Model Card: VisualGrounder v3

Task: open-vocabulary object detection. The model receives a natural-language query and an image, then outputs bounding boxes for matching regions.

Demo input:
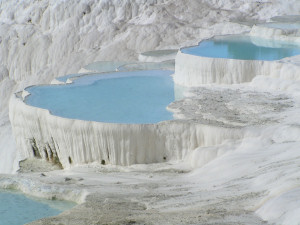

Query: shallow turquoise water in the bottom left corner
[0,190,74,225]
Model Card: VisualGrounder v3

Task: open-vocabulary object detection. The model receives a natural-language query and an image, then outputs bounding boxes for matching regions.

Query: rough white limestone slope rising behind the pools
[0,0,278,173]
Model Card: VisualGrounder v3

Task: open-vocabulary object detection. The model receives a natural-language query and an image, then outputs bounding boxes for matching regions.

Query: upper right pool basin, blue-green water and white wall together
[174,35,300,86]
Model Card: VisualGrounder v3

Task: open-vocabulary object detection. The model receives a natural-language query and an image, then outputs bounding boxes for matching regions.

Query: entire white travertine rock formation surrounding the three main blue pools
[0,0,300,225]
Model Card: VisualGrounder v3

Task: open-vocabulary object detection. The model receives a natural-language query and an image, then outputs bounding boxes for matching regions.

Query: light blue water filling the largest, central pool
[25,70,174,124]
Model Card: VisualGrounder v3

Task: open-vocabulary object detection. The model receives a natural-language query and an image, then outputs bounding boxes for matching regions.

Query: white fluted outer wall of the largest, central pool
[9,92,243,168]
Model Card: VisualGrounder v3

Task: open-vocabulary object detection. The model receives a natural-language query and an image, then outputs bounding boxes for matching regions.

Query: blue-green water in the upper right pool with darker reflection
[181,36,300,61]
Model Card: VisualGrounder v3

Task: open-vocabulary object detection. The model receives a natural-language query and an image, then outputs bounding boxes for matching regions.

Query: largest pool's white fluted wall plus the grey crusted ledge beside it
[9,63,291,171]
